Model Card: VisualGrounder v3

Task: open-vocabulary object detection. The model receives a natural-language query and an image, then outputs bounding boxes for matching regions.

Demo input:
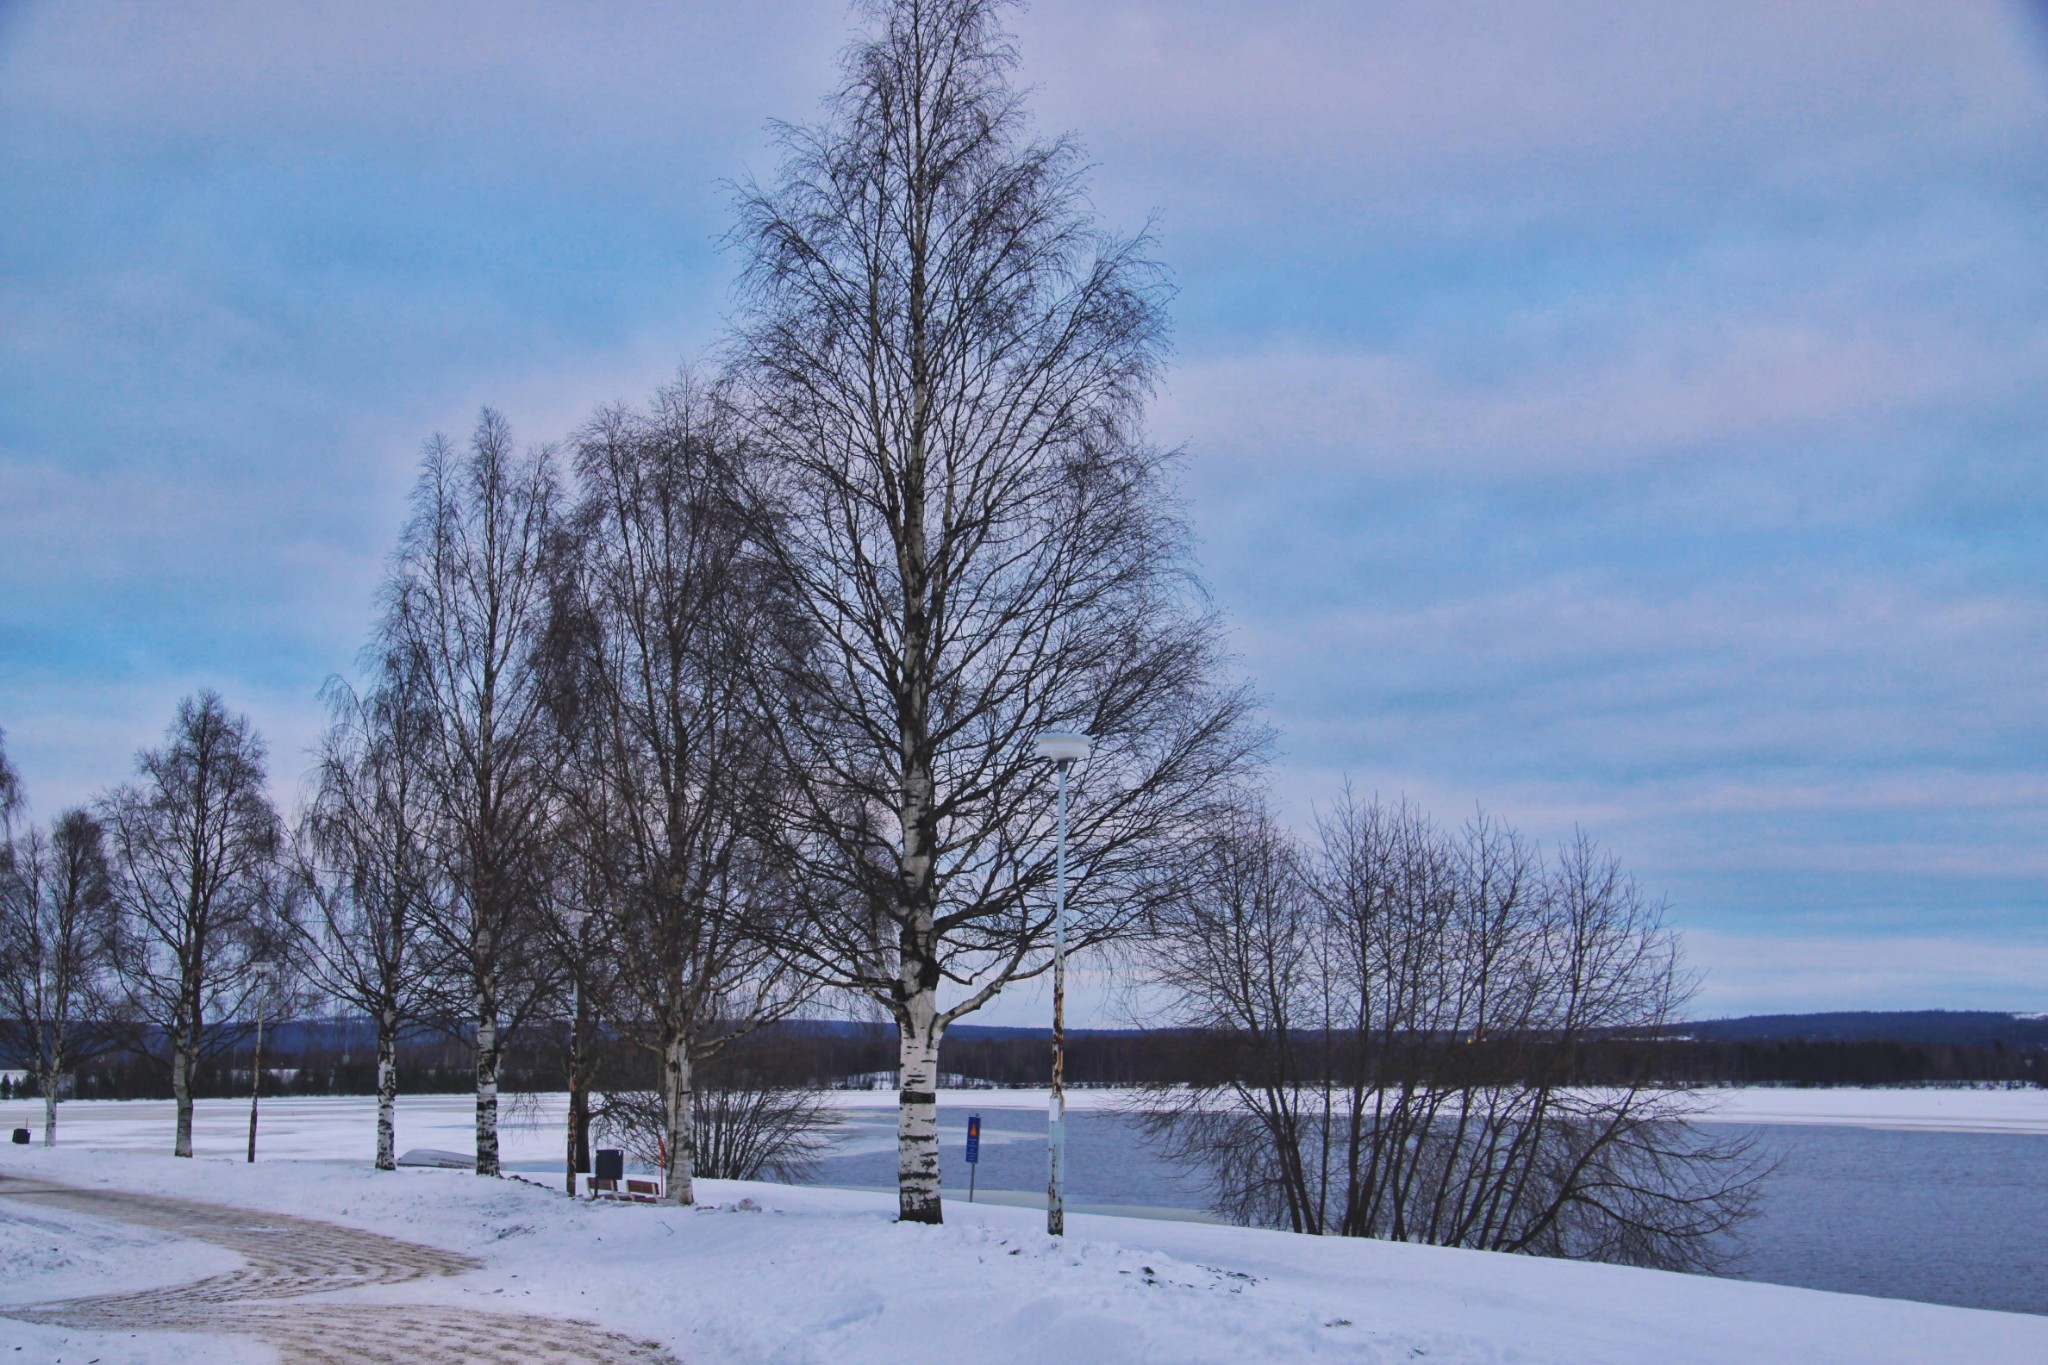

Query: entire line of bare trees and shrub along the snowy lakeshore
[0,0,1757,1265]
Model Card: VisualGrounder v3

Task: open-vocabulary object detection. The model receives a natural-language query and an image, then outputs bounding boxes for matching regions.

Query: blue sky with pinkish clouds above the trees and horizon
[0,0,2048,1021]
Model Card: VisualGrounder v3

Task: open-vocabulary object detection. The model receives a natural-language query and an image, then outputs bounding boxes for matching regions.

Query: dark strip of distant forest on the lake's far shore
[12,1011,2048,1099]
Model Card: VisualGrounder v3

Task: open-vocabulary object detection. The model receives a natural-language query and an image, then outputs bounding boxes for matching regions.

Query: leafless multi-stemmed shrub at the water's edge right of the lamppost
[1149,796,1765,1269]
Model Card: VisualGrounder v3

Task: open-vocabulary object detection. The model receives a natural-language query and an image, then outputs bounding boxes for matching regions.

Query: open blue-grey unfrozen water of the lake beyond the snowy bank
[817,1103,2048,1314]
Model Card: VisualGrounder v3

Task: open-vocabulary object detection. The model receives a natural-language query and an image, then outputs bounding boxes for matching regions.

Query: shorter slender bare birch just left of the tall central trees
[289,679,444,1171]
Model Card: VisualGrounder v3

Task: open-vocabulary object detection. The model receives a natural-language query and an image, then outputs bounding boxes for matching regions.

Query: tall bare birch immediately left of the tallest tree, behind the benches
[557,377,805,1203]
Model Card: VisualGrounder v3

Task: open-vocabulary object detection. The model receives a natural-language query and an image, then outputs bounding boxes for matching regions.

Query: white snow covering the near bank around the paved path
[0,1146,2048,1365]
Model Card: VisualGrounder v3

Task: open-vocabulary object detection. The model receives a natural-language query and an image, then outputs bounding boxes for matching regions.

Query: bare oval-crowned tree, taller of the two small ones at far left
[98,692,281,1156]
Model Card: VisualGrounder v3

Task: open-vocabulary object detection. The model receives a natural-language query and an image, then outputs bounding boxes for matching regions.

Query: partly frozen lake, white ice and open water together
[19,1091,2048,1314]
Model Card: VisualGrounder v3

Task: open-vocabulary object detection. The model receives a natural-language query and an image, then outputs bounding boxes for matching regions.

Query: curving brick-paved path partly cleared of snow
[0,1177,674,1365]
